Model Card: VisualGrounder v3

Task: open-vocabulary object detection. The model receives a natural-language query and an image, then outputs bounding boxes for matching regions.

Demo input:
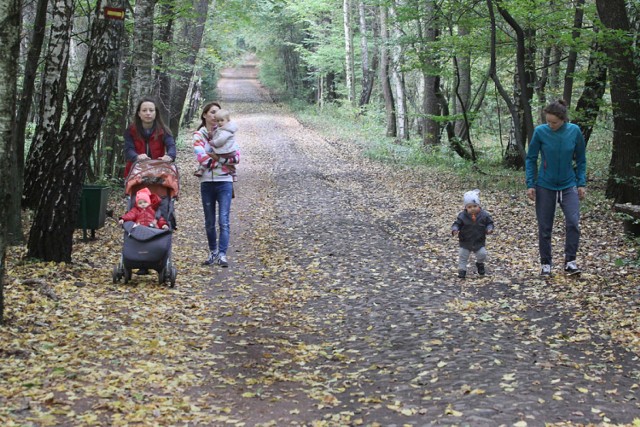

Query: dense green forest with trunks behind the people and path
[0,0,640,314]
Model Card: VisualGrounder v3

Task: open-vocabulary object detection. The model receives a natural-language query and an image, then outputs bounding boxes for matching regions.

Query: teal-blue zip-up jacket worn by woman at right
[525,122,587,191]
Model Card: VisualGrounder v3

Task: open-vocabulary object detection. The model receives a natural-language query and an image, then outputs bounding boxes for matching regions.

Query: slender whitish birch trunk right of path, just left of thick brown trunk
[389,1,409,139]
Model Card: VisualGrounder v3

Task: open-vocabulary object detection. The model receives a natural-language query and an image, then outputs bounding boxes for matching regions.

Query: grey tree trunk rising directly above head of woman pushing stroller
[129,0,156,110]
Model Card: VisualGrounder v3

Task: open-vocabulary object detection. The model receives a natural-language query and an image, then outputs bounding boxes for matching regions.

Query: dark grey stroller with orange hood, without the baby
[113,160,180,287]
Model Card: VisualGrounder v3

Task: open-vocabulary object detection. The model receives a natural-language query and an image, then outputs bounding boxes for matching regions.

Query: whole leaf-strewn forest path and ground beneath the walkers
[0,57,640,427]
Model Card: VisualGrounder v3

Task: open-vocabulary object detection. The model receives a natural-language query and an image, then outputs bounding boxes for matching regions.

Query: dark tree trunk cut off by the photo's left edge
[0,0,21,324]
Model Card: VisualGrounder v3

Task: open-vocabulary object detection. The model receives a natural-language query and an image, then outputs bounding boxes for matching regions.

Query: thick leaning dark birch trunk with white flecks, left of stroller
[27,0,124,262]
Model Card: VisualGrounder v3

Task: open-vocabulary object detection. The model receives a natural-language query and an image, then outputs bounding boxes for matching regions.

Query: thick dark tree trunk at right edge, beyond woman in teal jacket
[596,0,640,204]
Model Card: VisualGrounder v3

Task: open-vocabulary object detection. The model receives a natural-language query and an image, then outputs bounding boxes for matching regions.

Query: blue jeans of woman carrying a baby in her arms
[200,181,233,254]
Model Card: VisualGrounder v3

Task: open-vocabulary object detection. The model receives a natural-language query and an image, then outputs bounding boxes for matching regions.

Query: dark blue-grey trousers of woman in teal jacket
[536,187,580,264]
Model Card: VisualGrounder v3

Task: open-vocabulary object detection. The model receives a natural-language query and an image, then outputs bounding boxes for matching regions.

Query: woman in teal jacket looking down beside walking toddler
[525,100,587,276]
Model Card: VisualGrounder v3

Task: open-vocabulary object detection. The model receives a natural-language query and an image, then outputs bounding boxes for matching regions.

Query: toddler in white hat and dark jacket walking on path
[451,190,493,279]
